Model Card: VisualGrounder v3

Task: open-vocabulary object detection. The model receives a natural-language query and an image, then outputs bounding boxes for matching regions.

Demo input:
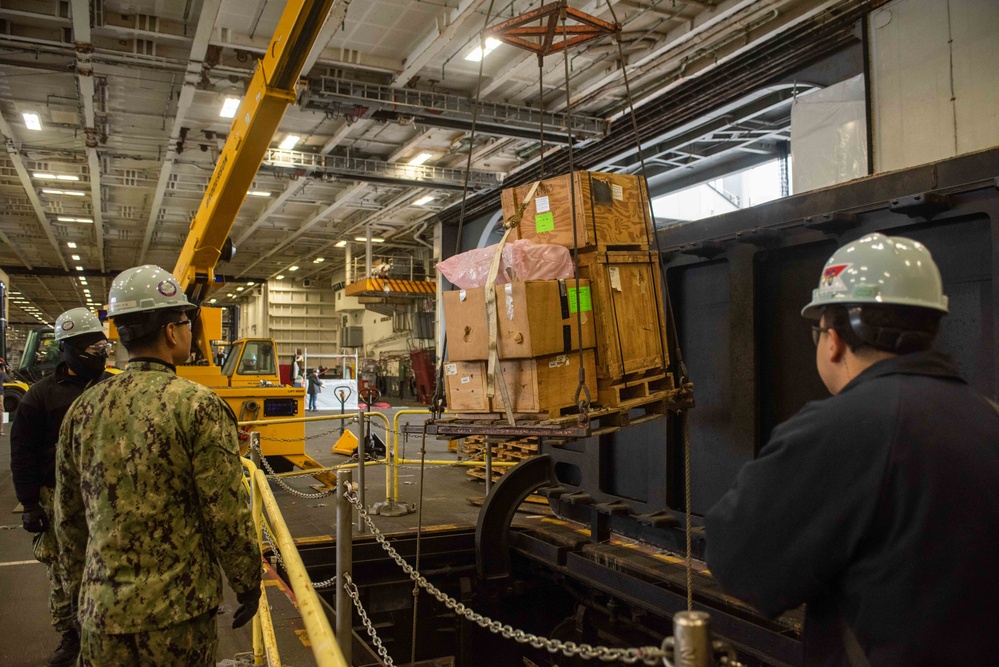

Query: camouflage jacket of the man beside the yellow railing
[55,359,261,634]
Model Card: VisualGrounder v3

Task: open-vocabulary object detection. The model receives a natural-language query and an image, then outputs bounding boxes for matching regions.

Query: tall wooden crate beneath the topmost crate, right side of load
[577,251,669,384]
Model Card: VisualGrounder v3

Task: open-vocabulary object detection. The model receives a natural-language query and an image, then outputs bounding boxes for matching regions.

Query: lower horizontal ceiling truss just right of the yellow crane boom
[263,148,501,190]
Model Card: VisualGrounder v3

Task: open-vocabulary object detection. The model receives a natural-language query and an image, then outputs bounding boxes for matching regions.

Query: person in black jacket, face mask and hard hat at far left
[10,308,111,667]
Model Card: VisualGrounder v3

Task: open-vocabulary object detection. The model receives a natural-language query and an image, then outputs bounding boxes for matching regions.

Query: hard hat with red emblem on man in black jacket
[801,234,947,320]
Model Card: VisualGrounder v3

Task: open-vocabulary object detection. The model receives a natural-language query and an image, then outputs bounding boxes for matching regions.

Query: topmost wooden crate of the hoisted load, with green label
[501,171,651,250]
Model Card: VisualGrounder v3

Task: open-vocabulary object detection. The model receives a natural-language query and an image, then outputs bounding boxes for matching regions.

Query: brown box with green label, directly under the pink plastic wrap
[444,278,595,361]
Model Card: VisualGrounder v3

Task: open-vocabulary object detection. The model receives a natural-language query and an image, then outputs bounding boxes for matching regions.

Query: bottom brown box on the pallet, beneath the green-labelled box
[444,350,596,414]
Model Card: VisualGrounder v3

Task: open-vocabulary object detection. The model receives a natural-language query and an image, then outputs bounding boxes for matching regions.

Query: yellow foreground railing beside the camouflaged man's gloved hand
[241,459,349,667]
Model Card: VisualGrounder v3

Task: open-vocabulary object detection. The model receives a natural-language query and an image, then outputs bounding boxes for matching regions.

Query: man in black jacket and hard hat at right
[705,234,999,667]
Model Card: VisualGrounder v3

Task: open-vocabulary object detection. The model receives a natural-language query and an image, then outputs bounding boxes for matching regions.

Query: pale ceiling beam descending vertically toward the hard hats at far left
[70,0,104,271]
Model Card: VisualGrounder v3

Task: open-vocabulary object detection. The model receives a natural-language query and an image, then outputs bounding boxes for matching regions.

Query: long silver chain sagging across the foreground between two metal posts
[343,487,666,665]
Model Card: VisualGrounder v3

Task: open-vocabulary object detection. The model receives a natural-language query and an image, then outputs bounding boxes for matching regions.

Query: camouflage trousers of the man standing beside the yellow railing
[77,611,218,667]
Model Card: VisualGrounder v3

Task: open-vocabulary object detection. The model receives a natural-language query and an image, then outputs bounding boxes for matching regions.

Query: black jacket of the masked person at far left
[10,362,111,505]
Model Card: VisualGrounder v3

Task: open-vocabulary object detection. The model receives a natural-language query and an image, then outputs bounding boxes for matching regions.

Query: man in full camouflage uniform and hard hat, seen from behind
[55,265,261,666]
